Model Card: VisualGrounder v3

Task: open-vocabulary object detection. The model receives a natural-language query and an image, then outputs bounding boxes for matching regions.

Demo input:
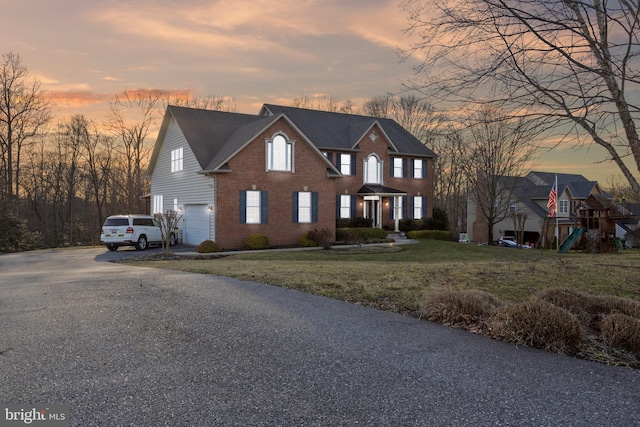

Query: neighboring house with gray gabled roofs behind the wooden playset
[467,172,609,244]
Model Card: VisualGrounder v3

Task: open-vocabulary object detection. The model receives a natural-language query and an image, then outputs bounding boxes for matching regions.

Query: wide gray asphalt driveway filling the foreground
[0,248,640,426]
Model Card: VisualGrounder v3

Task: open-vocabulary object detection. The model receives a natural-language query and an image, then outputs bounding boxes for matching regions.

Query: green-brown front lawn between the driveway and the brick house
[129,240,640,315]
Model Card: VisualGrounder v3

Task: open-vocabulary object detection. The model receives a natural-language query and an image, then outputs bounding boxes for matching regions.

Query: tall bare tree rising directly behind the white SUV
[104,90,163,212]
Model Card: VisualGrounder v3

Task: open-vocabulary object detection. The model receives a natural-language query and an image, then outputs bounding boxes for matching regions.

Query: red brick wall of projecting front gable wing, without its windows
[216,119,336,249]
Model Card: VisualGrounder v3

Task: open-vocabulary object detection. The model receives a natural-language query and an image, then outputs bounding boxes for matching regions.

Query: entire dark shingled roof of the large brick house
[148,104,435,176]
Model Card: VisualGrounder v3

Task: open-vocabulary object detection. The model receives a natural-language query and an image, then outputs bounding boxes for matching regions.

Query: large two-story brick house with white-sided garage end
[148,104,435,249]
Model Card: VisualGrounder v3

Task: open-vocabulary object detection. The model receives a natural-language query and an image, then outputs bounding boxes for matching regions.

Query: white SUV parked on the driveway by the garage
[100,215,176,251]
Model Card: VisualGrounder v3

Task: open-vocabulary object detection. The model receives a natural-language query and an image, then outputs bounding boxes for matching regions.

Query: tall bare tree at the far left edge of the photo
[0,52,51,211]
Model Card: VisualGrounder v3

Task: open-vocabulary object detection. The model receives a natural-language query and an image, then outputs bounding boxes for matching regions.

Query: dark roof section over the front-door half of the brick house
[260,104,436,157]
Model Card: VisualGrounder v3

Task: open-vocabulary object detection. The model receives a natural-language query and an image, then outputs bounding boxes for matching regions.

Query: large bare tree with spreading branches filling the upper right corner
[402,0,640,193]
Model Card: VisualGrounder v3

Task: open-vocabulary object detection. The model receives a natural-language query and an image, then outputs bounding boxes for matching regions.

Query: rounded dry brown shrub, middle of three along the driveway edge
[487,300,584,353]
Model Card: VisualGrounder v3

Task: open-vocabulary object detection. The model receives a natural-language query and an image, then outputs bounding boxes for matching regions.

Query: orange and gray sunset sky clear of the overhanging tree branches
[0,0,618,184]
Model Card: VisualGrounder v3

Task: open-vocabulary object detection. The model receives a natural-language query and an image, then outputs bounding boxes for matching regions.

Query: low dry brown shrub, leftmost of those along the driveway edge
[420,290,502,328]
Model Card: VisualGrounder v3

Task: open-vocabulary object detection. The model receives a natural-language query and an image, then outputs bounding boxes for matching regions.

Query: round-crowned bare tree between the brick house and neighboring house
[460,107,539,244]
